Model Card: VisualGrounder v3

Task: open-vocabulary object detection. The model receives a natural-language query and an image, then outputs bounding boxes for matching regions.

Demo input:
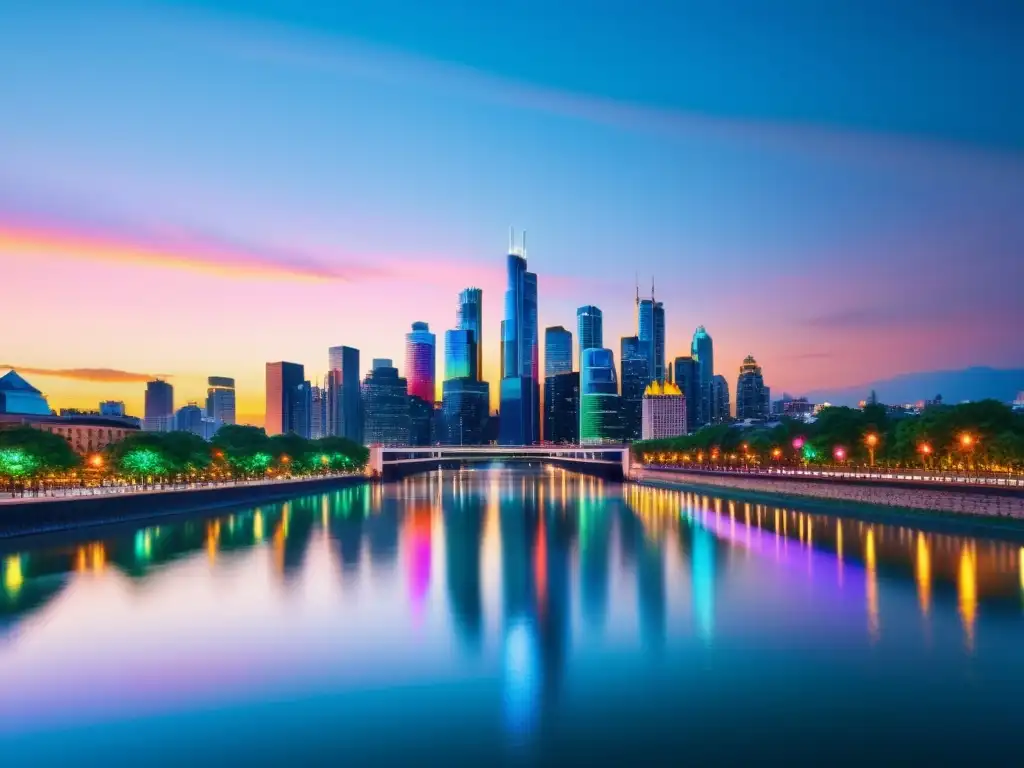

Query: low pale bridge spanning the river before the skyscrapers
[370,445,630,480]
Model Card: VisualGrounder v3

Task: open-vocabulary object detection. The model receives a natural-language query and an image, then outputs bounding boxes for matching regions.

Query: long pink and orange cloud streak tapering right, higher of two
[0,221,381,281]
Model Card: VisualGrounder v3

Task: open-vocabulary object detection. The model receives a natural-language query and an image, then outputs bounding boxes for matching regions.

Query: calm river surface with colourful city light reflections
[0,468,1024,765]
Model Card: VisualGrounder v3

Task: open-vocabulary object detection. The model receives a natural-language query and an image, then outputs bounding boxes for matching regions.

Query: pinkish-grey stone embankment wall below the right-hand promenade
[633,470,1024,520]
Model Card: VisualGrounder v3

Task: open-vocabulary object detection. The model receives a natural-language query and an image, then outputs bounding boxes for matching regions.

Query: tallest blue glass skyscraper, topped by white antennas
[500,231,541,445]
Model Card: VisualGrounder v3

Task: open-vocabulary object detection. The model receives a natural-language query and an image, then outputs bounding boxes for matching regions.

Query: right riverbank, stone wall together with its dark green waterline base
[633,470,1024,530]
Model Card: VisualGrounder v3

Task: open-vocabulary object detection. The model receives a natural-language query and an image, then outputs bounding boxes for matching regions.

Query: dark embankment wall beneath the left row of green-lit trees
[0,475,369,539]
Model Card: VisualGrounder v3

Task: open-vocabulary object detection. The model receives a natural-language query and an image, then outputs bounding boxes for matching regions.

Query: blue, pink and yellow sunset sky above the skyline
[0,0,1024,423]
